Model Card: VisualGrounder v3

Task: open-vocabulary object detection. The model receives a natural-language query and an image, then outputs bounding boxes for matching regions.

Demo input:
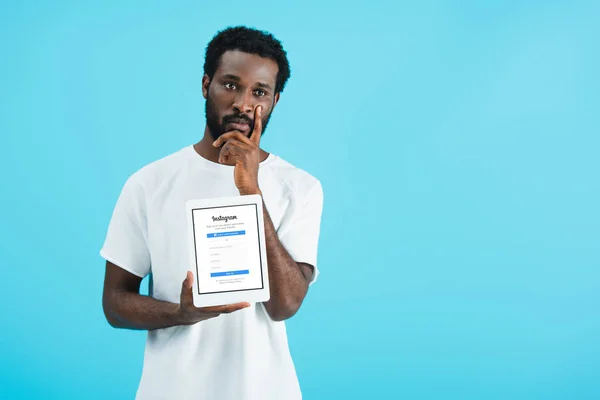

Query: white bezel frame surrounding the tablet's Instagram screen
[186,194,270,307]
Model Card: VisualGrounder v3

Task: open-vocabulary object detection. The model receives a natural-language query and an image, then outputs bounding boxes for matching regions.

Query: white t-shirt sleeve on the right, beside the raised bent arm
[278,181,323,284]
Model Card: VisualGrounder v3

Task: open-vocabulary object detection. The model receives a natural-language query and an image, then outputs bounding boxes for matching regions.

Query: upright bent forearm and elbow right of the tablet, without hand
[263,198,308,321]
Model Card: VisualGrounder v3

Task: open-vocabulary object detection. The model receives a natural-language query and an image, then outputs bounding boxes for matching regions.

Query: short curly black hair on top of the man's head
[204,26,290,93]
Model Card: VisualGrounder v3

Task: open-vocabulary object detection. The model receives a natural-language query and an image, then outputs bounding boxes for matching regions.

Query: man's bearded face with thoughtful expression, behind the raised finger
[202,50,279,140]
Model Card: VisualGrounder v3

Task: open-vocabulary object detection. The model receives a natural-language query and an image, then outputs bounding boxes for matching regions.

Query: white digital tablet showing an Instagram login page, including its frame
[186,195,270,307]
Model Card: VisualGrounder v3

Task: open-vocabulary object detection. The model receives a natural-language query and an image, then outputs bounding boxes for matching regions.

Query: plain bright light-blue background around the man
[0,0,600,399]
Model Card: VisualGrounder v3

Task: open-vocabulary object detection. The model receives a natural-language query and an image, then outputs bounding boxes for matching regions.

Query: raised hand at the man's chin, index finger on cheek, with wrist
[213,106,262,195]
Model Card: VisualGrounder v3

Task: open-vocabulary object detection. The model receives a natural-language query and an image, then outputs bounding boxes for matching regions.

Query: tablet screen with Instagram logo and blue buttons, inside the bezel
[192,204,264,294]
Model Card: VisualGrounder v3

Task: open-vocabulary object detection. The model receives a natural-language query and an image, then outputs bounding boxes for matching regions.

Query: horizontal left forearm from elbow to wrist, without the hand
[103,291,183,330]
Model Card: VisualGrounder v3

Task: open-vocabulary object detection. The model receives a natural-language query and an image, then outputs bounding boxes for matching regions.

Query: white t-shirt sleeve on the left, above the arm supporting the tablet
[100,175,150,278]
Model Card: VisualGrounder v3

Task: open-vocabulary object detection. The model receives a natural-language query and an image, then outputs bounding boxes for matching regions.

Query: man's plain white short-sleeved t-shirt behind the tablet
[100,146,323,400]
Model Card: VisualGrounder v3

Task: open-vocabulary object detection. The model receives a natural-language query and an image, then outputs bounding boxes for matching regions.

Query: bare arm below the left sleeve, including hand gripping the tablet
[102,261,250,330]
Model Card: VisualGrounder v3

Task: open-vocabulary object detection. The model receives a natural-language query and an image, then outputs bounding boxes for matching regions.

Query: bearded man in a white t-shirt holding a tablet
[100,27,323,400]
